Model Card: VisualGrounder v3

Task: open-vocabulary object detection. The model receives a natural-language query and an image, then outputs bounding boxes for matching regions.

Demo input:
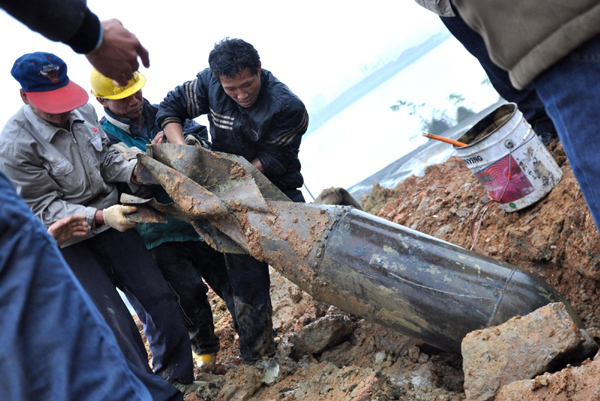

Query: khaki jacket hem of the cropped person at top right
[453,0,600,89]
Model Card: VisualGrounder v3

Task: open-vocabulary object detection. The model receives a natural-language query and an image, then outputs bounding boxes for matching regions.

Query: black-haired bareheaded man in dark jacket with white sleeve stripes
[157,38,308,362]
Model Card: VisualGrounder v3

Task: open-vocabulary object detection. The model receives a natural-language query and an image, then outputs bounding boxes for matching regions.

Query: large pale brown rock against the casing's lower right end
[461,303,595,401]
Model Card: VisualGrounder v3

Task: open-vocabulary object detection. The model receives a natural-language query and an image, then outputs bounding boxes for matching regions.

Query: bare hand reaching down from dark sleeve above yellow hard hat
[85,18,150,86]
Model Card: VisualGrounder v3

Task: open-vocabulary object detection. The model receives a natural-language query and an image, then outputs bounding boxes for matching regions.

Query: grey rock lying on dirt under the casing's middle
[288,315,353,356]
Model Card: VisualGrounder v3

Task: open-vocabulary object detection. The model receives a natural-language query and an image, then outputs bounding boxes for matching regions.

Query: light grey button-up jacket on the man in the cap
[0,104,135,245]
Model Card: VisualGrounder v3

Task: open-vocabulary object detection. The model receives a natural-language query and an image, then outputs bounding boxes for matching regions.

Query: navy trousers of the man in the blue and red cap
[61,229,194,383]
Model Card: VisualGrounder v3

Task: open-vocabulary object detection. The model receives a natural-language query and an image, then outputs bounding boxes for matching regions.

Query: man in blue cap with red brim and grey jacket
[0,52,202,396]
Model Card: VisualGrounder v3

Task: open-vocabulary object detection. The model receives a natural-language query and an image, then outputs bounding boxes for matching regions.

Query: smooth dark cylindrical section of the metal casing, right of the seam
[311,210,579,353]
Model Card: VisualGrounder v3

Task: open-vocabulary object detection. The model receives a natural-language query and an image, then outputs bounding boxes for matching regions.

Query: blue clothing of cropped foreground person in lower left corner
[0,172,183,401]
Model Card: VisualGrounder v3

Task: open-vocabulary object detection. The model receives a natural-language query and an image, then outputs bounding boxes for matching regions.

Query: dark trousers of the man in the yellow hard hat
[150,241,234,355]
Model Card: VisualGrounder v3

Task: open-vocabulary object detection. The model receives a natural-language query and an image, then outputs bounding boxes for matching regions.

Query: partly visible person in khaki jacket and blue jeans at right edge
[453,0,600,234]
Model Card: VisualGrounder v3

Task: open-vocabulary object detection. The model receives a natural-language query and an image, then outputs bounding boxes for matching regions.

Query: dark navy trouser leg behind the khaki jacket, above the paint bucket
[440,13,556,135]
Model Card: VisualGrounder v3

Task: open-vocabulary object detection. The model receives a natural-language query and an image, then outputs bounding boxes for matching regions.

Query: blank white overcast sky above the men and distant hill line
[0,0,444,123]
